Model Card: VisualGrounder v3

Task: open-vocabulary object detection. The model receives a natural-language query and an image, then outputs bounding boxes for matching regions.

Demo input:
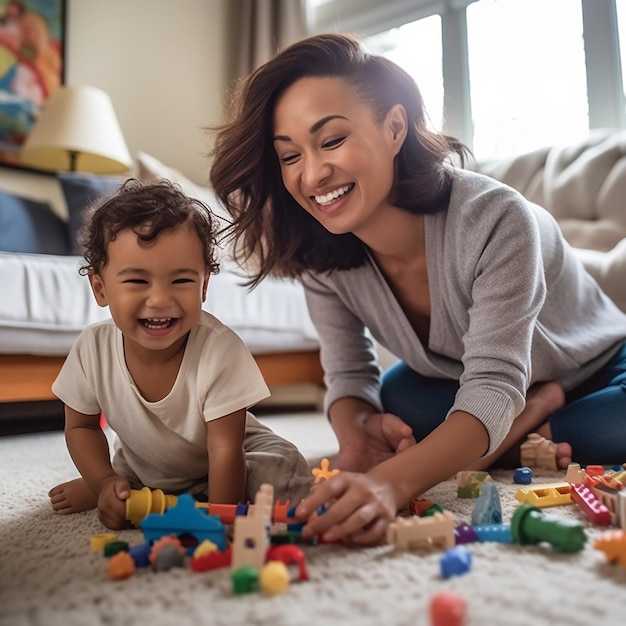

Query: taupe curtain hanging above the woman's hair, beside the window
[233,0,307,78]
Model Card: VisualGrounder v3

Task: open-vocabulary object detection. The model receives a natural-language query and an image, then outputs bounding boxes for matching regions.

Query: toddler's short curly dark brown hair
[77,178,219,275]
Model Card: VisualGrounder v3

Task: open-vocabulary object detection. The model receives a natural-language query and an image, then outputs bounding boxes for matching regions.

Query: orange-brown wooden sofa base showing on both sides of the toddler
[0,350,324,402]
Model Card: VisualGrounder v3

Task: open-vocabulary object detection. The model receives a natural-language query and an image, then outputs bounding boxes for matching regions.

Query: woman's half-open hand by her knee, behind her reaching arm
[333,413,415,472]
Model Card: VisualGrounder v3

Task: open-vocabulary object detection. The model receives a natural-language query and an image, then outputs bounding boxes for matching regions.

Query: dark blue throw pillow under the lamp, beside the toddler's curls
[57,172,124,254]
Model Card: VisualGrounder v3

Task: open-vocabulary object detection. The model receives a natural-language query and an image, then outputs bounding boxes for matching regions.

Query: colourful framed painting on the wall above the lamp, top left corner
[0,0,66,167]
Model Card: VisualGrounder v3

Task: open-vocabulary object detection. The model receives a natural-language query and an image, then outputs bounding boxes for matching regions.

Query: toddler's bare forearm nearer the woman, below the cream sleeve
[207,409,246,504]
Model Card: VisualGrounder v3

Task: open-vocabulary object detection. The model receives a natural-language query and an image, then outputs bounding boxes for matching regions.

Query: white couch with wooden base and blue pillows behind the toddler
[0,152,323,431]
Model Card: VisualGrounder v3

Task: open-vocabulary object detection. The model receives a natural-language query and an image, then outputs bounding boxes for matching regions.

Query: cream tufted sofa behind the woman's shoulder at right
[474,130,626,311]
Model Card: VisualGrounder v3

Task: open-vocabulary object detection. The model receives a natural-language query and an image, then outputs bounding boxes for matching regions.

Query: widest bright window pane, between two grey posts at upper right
[467,0,589,158]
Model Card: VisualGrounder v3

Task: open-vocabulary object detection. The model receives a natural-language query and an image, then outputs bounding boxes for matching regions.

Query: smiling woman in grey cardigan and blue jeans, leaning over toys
[211,35,626,543]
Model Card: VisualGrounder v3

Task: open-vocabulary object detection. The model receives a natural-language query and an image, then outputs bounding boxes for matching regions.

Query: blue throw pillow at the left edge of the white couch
[0,190,70,254]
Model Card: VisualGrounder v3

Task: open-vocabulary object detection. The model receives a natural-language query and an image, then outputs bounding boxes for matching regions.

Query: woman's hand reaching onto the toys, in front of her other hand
[296,472,396,545]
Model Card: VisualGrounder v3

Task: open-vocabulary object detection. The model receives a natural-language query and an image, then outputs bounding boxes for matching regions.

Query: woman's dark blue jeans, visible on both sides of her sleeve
[381,344,626,465]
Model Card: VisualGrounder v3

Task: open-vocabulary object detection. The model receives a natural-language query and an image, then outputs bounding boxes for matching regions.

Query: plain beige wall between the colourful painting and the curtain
[65,0,230,183]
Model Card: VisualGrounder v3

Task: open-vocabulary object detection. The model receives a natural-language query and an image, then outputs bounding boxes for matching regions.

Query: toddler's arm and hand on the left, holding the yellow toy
[65,406,130,529]
